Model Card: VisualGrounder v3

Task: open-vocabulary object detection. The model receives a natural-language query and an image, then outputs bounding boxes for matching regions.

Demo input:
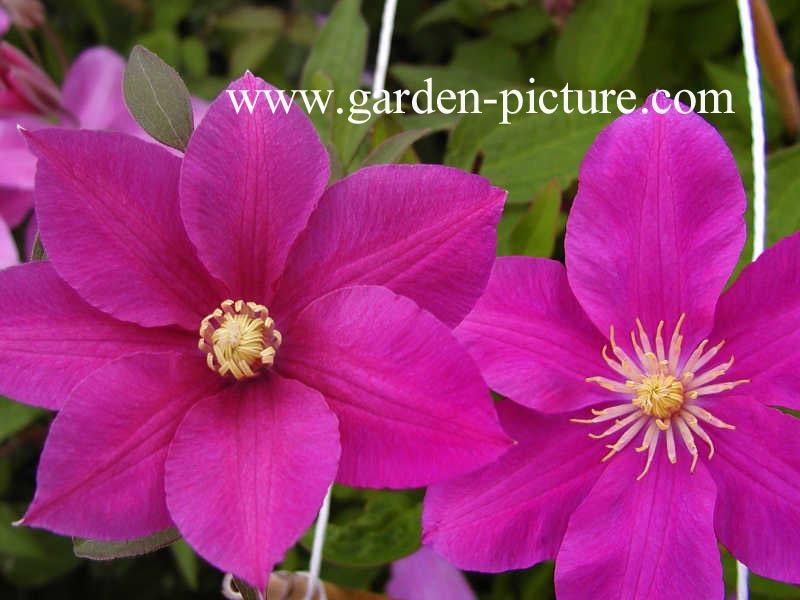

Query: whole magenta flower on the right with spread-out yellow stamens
[423,99,800,600]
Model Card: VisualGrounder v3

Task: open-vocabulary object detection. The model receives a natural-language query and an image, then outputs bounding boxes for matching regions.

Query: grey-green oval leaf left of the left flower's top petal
[122,46,194,151]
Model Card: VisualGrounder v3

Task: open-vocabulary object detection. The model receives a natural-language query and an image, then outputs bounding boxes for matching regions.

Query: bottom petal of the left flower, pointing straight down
[166,373,339,589]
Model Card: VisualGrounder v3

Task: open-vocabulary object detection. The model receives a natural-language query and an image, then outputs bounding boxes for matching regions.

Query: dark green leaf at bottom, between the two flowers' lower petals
[303,490,422,567]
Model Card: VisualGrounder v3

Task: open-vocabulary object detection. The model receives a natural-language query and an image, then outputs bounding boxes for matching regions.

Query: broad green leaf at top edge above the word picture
[556,0,650,89]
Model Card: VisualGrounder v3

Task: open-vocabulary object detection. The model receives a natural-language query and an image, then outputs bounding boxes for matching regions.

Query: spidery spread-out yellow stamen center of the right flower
[572,315,748,479]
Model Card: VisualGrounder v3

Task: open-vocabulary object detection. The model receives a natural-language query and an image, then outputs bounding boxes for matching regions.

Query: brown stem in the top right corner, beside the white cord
[750,0,800,138]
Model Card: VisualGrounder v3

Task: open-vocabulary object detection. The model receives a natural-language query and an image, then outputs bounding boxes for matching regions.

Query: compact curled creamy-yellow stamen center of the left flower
[197,300,282,379]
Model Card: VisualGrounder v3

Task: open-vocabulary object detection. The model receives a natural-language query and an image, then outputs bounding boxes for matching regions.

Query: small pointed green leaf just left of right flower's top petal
[509,181,561,258]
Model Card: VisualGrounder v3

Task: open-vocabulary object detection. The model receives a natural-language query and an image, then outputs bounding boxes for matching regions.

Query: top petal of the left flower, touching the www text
[181,73,329,308]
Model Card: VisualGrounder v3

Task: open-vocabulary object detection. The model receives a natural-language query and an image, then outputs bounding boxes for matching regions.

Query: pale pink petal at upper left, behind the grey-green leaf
[62,46,140,137]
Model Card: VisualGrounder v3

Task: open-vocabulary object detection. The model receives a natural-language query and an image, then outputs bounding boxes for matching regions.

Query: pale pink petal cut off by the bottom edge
[386,546,477,600]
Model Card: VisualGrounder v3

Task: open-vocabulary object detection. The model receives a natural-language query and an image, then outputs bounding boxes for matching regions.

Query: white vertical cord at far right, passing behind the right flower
[736,0,767,600]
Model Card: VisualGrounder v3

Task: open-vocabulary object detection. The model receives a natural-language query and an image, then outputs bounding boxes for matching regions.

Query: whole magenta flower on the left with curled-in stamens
[0,75,509,588]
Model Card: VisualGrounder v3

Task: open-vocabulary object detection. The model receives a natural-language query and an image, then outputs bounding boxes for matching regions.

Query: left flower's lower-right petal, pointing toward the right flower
[275,286,509,488]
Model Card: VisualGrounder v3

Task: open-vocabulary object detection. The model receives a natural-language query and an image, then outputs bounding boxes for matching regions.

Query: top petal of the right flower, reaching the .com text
[566,96,746,345]
